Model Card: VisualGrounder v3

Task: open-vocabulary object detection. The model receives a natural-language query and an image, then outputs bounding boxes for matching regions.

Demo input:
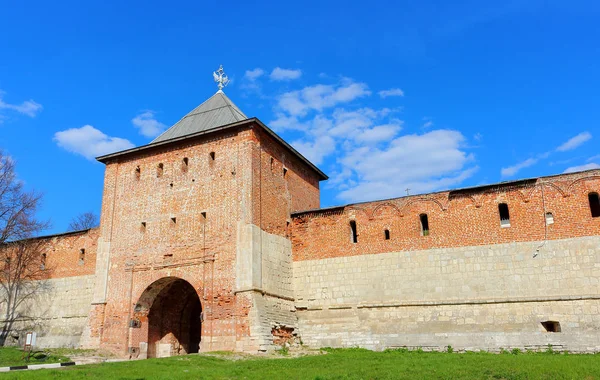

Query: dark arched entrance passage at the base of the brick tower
[133,277,202,358]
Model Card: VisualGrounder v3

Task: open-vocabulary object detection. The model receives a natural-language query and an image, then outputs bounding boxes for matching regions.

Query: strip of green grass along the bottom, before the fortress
[0,349,600,380]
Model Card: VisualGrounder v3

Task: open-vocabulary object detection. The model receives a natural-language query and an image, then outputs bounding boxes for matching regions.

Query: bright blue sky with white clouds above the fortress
[0,0,600,232]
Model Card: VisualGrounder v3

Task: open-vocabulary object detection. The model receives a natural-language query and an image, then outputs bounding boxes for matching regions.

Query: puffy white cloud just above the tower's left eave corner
[54,125,134,160]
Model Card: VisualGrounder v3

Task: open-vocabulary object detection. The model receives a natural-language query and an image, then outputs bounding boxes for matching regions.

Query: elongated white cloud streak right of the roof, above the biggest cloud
[278,82,371,116]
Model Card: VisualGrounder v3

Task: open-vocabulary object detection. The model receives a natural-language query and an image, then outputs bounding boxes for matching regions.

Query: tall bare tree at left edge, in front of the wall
[0,151,48,346]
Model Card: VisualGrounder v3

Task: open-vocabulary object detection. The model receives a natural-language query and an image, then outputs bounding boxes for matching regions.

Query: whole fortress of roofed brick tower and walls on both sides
[2,87,600,358]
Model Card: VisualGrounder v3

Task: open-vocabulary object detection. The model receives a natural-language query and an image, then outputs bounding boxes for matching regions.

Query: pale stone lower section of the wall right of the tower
[294,236,600,351]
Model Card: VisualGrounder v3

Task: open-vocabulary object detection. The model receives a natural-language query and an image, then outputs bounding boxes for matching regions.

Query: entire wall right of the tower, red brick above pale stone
[292,172,600,351]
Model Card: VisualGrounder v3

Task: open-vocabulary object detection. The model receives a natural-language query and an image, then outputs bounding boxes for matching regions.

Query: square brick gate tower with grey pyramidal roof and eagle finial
[82,69,327,358]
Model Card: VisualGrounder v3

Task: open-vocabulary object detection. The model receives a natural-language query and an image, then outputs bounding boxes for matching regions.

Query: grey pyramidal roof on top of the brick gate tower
[152,90,248,143]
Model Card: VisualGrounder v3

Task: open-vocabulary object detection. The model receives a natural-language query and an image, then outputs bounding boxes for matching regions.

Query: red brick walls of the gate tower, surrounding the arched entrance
[90,126,319,353]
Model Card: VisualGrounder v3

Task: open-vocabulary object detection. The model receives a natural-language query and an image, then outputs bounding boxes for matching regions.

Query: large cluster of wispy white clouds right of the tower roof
[269,78,478,202]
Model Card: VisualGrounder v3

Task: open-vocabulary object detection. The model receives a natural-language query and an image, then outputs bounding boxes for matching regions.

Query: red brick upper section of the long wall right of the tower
[292,170,600,261]
